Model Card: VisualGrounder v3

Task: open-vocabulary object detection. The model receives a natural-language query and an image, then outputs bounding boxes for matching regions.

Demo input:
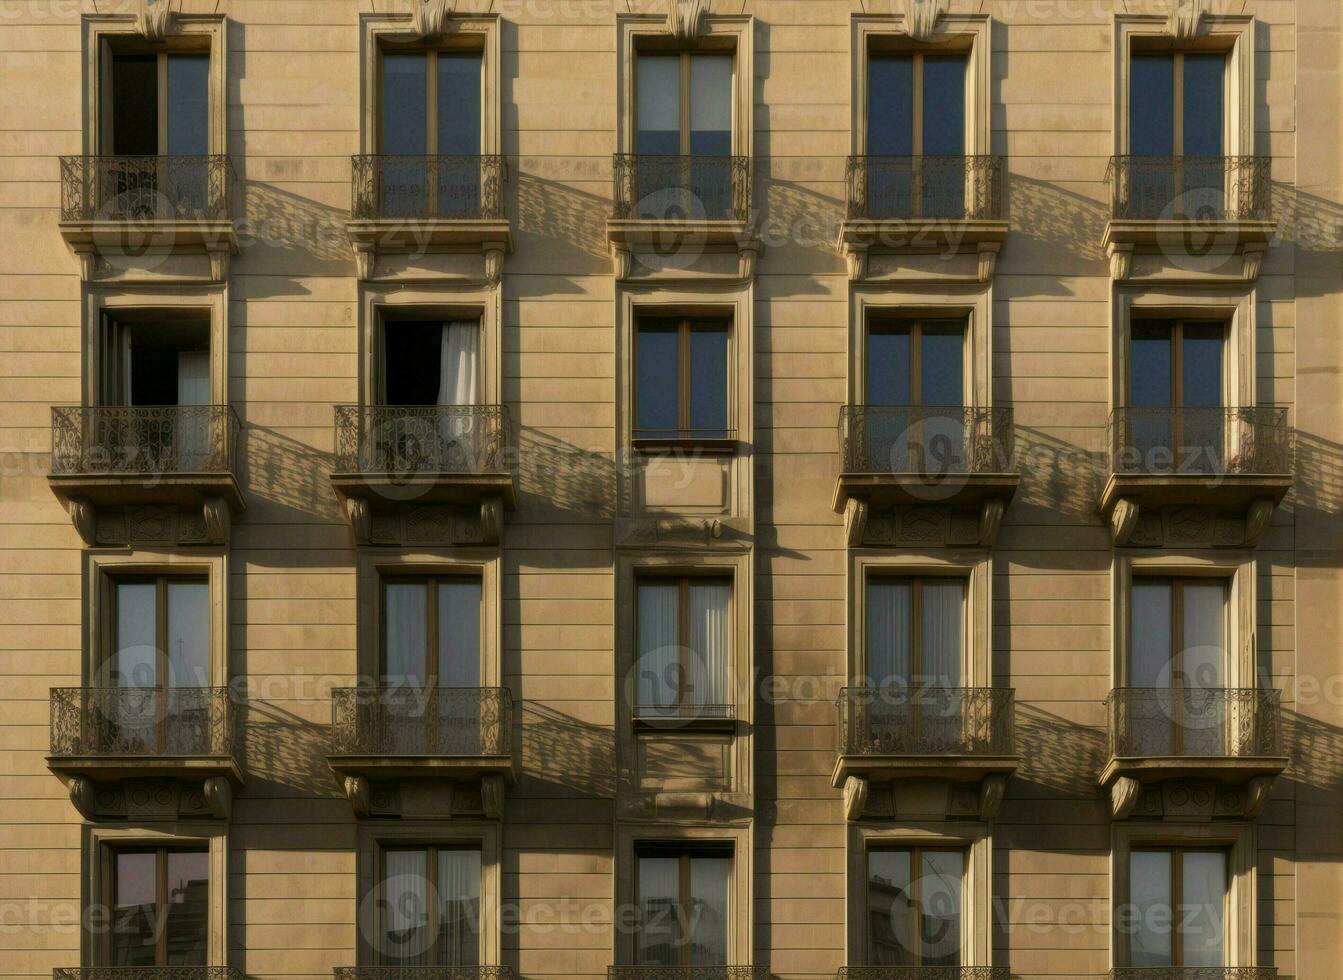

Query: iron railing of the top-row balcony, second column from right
[845,156,1007,220]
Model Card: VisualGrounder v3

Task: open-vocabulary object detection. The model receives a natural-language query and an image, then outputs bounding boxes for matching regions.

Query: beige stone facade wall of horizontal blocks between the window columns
[0,0,1343,980]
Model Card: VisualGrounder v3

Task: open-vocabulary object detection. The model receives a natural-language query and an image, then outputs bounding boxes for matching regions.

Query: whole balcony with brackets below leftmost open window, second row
[47,405,244,545]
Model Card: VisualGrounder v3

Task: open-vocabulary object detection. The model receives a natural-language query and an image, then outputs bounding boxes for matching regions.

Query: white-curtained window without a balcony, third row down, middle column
[635,577,732,716]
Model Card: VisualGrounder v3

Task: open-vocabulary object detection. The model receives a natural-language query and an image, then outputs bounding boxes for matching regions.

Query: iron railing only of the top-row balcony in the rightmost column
[1105,157,1272,222]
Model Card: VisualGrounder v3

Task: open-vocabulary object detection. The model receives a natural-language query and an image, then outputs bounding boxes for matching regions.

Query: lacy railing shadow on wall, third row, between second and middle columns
[520,701,615,800]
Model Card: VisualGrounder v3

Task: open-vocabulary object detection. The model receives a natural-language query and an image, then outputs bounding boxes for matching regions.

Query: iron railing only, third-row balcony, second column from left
[332,687,513,757]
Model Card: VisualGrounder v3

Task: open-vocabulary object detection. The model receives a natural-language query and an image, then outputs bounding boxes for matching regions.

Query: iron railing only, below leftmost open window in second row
[51,405,239,474]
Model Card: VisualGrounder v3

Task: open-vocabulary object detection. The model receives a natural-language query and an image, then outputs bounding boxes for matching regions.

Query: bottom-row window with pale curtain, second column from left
[377,846,481,967]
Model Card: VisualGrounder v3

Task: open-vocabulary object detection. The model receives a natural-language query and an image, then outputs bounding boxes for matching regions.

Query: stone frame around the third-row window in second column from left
[355,548,505,687]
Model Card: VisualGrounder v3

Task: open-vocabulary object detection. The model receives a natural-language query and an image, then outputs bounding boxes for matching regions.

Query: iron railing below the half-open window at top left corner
[60,154,234,222]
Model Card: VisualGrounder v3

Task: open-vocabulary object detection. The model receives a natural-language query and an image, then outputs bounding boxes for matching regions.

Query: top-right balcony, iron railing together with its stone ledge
[1103,156,1273,252]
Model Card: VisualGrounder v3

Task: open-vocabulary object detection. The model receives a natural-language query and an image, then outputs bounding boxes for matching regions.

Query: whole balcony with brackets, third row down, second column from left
[326,687,514,816]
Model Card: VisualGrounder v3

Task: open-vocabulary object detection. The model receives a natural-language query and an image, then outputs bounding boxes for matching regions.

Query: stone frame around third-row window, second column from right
[846,548,994,687]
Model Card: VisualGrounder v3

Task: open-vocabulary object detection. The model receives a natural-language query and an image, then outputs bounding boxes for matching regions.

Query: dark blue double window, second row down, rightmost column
[1124,320,1229,473]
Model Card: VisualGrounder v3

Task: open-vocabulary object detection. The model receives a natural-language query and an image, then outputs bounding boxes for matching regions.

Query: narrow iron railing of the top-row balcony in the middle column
[614,153,751,222]
